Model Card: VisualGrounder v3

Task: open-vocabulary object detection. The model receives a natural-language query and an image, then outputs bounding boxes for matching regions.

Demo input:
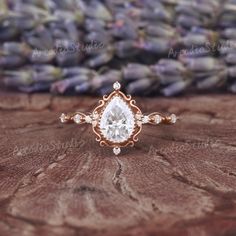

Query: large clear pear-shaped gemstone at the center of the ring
[100,96,135,143]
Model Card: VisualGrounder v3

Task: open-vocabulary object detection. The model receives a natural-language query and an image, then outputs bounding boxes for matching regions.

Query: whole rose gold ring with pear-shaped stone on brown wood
[60,82,177,155]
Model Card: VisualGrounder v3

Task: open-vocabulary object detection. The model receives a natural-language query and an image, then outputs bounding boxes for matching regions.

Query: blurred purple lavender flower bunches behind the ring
[0,0,236,96]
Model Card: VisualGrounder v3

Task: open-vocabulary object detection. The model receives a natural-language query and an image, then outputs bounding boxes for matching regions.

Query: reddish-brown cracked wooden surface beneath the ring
[0,92,236,236]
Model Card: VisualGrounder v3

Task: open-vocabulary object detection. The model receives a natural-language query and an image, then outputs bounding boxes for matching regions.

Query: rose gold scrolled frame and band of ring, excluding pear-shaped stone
[60,82,177,155]
